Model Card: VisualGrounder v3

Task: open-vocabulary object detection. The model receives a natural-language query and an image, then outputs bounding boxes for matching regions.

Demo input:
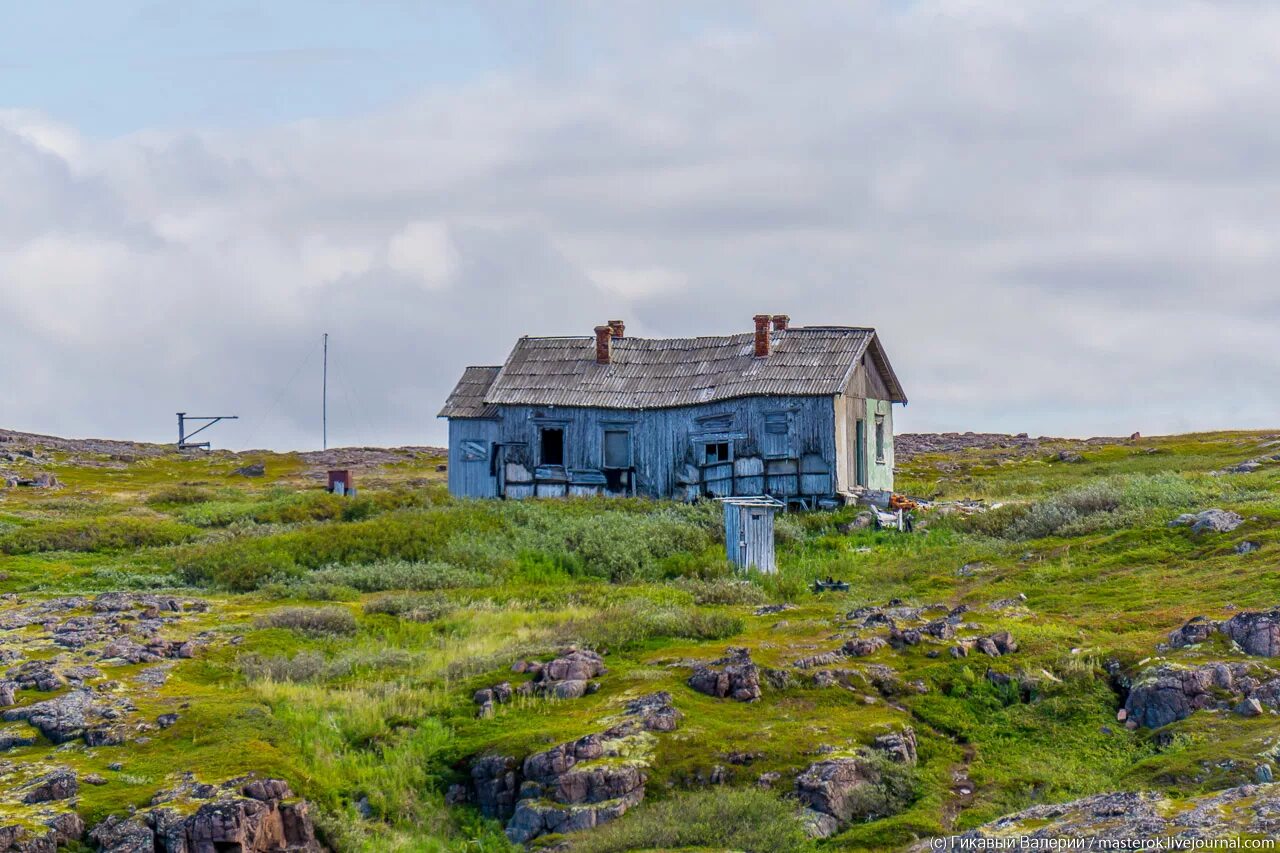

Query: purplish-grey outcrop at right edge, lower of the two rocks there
[1124,663,1280,729]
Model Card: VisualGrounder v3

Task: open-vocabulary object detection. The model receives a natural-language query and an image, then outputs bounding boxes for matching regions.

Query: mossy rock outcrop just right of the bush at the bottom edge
[795,729,916,838]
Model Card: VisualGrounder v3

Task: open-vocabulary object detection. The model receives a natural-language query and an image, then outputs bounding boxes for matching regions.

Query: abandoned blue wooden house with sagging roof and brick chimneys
[440,314,906,506]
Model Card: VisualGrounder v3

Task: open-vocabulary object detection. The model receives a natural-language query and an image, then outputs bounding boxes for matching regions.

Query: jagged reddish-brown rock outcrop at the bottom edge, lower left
[90,779,323,853]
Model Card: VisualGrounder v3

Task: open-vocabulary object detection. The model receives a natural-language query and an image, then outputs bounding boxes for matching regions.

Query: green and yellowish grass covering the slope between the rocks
[0,433,1280,852]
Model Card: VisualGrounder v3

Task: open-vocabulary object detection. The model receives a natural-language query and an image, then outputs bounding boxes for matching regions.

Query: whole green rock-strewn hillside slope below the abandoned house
[0,433,1280,852]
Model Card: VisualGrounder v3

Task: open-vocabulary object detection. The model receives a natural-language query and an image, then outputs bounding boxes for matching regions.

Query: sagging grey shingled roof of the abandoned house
[440,327,906,418]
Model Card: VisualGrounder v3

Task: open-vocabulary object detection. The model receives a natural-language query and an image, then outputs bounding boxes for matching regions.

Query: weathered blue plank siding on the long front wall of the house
[449,397,837,498]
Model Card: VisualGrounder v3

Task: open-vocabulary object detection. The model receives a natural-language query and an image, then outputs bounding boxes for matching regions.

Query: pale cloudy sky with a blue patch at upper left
[0,0,1280,450]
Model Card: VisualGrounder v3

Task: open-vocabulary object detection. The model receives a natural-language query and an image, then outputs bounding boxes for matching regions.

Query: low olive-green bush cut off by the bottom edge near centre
[573,788,815,853]
